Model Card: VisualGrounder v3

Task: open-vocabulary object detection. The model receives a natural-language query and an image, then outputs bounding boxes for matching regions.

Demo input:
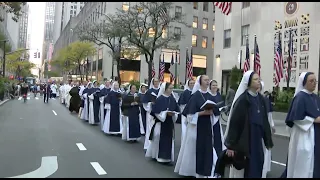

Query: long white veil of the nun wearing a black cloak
[224,70,254,138]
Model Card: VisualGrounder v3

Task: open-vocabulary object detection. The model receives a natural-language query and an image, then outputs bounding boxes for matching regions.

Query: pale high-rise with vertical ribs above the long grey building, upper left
[53,2,85,43]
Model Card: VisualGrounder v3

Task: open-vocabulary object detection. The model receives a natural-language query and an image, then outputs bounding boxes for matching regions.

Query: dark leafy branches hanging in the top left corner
[0,2,27,22]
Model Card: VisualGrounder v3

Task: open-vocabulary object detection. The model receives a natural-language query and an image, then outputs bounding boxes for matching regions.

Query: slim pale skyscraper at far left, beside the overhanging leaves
[18,4,29,49]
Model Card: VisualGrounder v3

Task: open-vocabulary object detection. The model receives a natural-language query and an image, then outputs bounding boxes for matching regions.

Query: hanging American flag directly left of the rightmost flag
[273,32,283,86]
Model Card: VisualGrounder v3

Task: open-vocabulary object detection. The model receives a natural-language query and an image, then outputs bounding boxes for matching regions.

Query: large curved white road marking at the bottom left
[9,156,58,178]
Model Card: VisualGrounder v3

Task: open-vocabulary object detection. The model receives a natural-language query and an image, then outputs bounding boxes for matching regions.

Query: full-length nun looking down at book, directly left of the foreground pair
[146,83,180,164]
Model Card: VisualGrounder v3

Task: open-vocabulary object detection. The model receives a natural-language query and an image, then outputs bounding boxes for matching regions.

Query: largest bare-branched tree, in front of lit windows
[116,2,190,83]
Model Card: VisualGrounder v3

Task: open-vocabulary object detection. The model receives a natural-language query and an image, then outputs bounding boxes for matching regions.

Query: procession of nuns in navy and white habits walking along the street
[73,71,320,178]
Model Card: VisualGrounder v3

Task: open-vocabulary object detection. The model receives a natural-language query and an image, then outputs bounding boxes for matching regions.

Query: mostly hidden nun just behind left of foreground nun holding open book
[178,79,194,143]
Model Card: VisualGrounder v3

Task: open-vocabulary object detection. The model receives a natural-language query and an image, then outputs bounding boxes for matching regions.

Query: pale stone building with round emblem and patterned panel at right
[213,2,320,92]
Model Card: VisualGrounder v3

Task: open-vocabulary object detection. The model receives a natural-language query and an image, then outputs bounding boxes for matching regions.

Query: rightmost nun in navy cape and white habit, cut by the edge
[282,72,320,178]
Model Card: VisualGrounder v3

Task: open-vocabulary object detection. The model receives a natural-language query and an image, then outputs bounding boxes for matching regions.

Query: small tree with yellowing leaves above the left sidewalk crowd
[6,49,35,77]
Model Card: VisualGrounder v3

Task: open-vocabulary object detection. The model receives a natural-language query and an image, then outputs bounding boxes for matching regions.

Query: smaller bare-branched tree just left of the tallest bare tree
[75,14,140,84]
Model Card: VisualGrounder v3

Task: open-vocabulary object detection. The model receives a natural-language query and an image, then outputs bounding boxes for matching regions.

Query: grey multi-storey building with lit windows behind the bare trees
[54,2,215,82]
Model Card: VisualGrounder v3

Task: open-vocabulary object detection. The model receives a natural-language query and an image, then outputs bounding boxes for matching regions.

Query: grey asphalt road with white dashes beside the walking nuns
[0,97,288,178]
